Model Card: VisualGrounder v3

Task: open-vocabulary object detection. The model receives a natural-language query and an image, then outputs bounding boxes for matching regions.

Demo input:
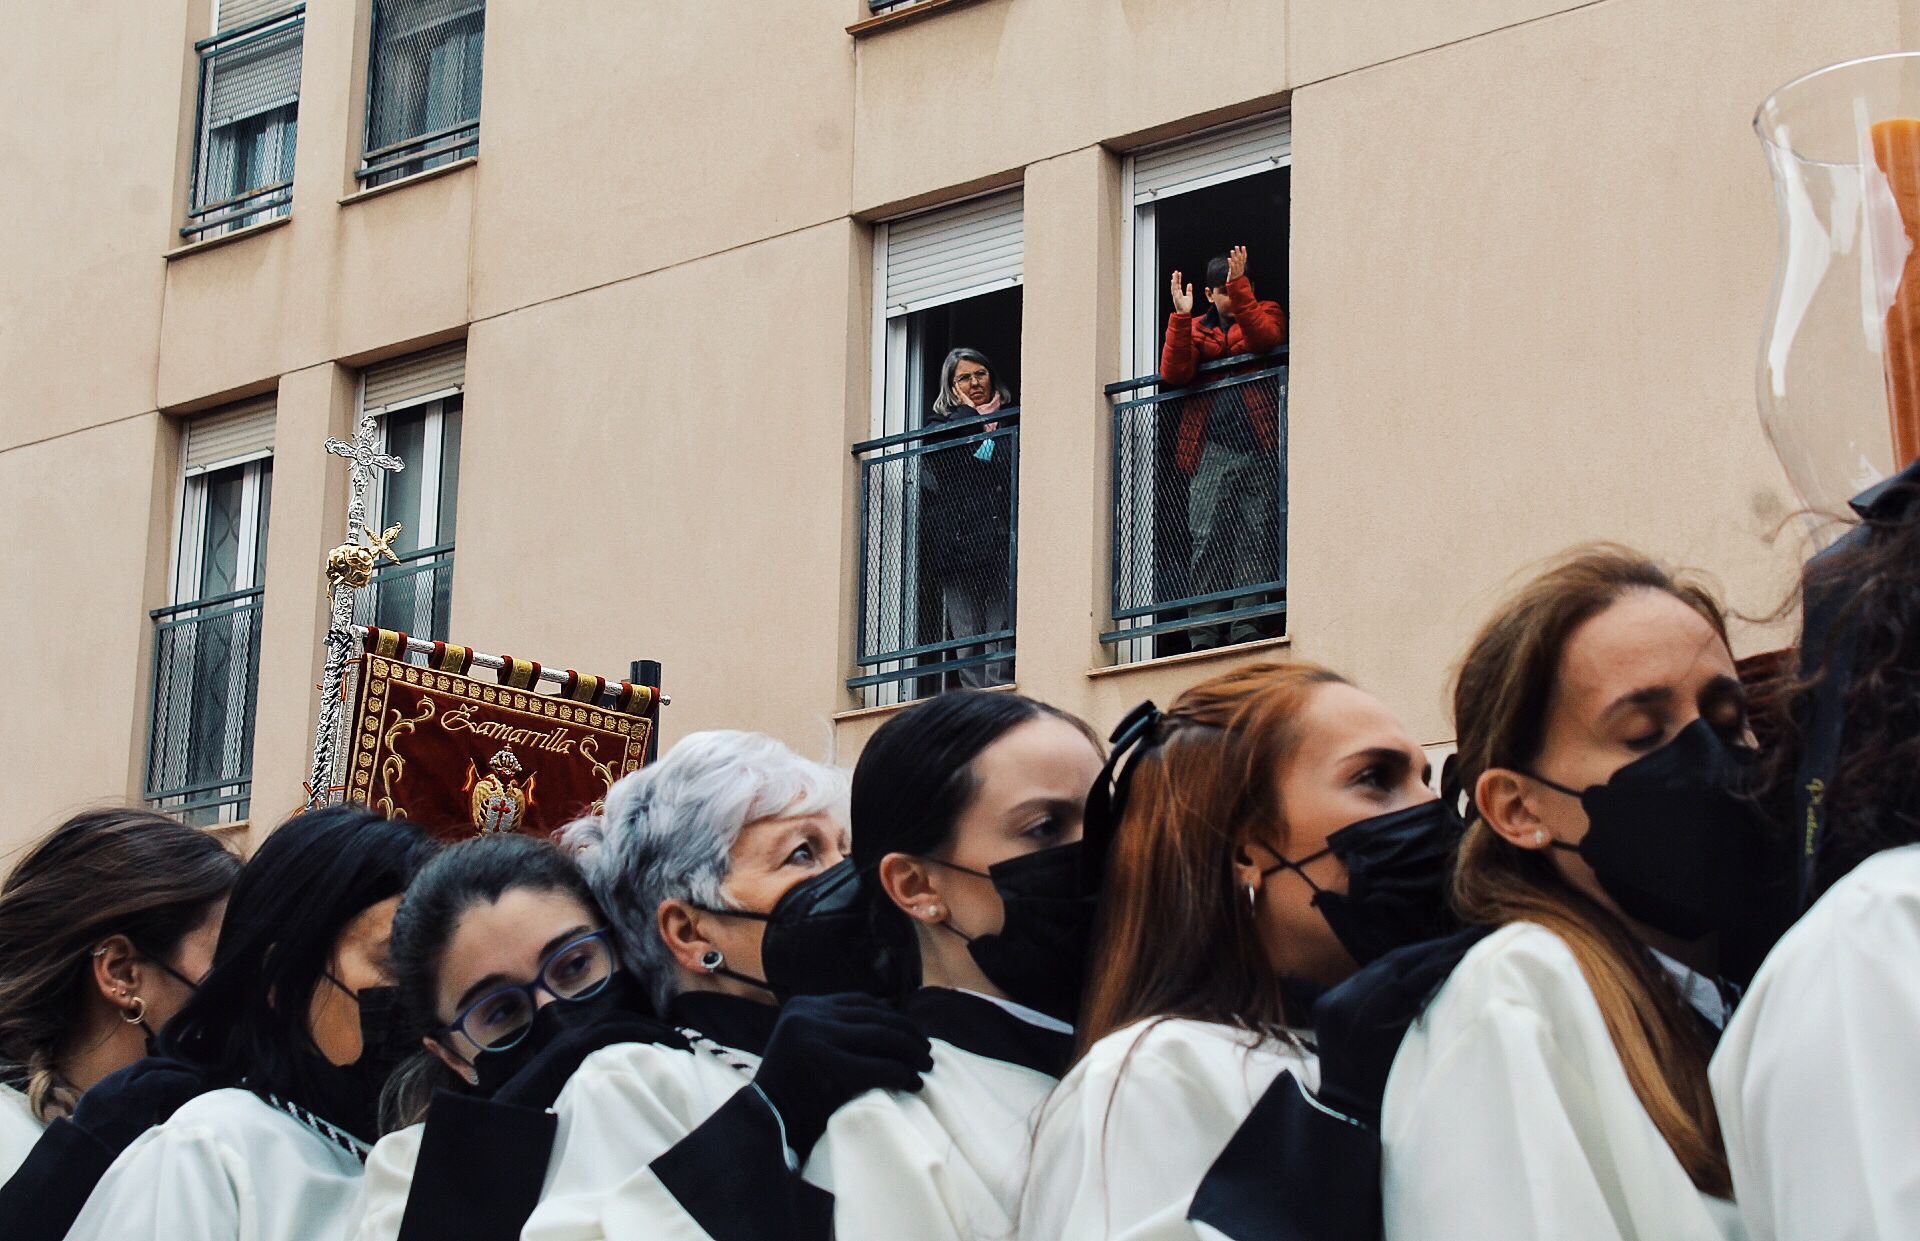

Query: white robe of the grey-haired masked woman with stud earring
[520,1037,772,1241]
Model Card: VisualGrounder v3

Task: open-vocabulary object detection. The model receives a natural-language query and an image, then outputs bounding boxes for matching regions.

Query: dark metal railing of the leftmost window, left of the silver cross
[146,588,263,822]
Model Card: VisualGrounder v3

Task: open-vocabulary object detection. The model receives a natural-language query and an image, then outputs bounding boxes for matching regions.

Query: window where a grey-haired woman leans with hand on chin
[849,190,1023,705]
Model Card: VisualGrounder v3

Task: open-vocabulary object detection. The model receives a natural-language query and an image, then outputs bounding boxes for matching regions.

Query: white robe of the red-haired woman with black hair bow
[1020,1018,1319,1241]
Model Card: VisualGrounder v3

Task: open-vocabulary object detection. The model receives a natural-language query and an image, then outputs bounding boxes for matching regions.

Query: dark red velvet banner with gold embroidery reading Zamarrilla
[348,655,653,840]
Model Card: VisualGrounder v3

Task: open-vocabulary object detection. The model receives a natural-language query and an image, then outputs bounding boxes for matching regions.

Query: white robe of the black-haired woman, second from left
[67,1089,361,1241]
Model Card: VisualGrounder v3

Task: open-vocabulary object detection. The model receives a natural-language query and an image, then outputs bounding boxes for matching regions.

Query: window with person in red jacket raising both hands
[1100,113,1292,663]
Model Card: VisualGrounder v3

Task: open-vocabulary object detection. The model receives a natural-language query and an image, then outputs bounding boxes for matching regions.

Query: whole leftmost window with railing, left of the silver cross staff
[146,398,273,824]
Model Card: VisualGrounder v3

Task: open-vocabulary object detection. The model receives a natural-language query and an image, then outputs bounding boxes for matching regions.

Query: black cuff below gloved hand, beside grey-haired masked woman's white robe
[651,1085,833,1241]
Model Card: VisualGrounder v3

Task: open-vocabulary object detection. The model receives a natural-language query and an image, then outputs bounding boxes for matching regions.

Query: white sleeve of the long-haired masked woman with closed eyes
[1380,999,1638,1241]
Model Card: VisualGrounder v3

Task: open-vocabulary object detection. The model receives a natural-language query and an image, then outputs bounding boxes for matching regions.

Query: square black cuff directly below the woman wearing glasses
[399,1091,559,1241]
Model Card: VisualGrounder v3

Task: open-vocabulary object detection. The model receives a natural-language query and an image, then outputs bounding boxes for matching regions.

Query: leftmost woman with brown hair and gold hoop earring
[0,809,240,1181]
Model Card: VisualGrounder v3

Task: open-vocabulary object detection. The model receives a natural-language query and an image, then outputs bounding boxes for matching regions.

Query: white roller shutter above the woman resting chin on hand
[885,190,1025,319]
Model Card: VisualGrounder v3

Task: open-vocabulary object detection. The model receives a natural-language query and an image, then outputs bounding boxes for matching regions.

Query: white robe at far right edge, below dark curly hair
[1713,845,1920,1241]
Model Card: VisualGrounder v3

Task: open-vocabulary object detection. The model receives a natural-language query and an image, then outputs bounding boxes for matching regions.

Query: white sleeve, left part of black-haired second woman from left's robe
[67,1126,245,1241]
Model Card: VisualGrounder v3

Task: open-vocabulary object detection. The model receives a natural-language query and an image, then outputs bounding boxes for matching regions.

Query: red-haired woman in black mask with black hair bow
[1020,663,1452,1241]
